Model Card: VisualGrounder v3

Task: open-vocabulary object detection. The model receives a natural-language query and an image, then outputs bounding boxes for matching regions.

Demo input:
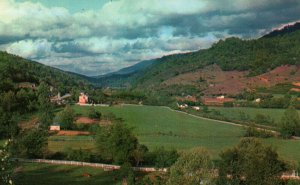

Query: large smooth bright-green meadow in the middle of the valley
[74,106,243,154]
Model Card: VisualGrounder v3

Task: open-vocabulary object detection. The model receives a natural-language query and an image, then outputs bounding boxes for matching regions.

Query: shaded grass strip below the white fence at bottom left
[14,163,122,185]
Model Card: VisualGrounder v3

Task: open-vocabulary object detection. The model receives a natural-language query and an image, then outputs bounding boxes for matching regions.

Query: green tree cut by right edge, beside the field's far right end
[280,107,300,138]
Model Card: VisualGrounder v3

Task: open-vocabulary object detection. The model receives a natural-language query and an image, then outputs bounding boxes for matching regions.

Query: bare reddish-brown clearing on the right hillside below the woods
[163,65,300,95]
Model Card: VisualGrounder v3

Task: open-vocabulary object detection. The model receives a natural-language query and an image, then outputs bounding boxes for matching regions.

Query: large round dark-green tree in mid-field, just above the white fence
[96,123,138,164]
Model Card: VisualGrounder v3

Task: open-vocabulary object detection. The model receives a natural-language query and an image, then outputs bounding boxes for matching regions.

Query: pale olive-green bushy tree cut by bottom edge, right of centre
[168,148,214,185]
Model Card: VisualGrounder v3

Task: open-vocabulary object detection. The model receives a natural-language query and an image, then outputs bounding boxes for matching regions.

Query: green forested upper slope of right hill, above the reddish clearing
[137,30,300,87]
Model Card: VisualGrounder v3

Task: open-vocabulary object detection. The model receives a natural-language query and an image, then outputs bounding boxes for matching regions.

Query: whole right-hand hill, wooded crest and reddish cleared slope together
[94,23,300,95]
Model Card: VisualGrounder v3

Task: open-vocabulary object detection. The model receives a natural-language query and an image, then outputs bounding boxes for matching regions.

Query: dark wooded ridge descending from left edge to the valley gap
[0,51,88,93]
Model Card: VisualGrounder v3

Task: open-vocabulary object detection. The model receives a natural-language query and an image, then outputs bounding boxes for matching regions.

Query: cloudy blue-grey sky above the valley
[0,0,300,76]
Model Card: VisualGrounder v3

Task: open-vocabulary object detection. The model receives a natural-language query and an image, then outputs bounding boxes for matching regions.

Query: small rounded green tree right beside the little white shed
[58,105,75,129]
